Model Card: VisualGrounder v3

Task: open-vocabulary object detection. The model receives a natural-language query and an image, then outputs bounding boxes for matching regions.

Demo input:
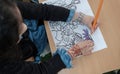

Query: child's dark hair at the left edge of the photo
[0,0,19,59]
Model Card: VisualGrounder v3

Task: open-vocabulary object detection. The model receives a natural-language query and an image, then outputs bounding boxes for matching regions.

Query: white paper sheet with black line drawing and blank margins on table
[43,0,107,52]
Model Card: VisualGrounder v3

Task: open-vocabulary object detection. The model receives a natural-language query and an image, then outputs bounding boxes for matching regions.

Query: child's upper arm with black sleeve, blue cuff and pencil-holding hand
[17,2,98,32]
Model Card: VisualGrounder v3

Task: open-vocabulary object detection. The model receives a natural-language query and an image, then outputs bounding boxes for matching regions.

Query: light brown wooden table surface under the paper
[39,0,120,74]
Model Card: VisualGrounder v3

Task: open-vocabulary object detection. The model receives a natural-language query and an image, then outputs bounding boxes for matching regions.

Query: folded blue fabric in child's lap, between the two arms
[24,19,48,62]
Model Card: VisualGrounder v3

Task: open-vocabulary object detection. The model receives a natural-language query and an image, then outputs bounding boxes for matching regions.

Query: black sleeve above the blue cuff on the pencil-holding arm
[17,2,70,21]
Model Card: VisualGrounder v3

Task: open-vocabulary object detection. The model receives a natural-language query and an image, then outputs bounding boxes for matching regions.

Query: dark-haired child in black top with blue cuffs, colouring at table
[0,0,97,74]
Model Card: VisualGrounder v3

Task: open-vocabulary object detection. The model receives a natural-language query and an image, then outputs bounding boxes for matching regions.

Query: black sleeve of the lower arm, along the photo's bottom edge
[5,54,65,74]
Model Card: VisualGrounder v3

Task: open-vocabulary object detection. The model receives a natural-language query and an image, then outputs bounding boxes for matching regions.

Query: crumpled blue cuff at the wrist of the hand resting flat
[55,48,72,68]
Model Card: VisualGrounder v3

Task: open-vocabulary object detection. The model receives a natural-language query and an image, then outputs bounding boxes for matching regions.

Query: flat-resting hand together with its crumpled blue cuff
[56,40,94,68]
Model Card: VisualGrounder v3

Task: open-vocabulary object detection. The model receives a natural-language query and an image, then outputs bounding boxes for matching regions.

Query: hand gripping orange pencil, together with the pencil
[74,0,103,34]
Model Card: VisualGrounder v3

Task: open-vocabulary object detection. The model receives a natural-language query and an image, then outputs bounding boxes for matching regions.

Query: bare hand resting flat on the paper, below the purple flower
[68,40,94,58]
